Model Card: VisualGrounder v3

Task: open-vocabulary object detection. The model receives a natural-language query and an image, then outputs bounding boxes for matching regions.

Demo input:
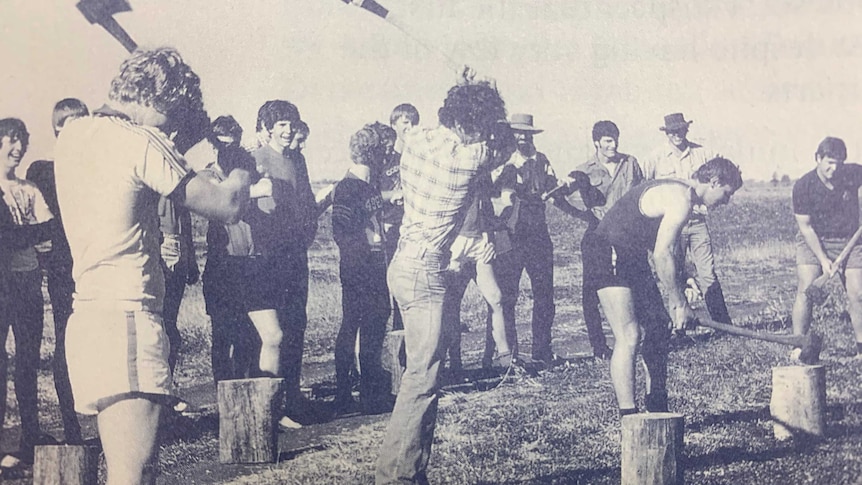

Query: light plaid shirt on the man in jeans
[401,126,487,251]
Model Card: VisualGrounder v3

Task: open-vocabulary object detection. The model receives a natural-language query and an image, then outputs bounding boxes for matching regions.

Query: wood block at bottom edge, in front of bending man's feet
[620,413,685,485]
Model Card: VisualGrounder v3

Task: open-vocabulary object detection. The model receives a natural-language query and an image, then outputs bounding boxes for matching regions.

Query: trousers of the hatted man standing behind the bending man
[678,217,732,324]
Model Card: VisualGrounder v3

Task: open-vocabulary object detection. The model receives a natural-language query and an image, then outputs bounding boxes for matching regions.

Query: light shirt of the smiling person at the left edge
[0,178,54,271]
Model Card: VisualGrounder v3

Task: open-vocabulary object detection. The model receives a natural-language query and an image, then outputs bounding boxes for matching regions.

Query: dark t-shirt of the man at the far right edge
[793,164,862,238]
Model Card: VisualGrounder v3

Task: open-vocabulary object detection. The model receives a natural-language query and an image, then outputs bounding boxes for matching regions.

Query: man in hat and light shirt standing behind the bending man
[642,113,732,324]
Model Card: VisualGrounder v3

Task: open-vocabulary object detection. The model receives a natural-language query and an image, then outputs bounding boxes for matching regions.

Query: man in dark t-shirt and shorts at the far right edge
[791,136,862,357]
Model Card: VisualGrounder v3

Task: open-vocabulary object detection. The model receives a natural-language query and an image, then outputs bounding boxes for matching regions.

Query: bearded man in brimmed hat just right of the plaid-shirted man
[494,113,557,366]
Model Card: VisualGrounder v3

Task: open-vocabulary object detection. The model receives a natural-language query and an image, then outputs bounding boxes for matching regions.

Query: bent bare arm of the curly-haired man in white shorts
[172,169,250,224]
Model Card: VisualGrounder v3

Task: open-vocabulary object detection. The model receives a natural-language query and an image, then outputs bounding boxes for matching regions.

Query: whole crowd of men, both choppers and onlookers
[0,48,862,484]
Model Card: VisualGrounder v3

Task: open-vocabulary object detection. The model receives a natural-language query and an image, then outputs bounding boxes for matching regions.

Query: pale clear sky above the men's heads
[0,0,862,180]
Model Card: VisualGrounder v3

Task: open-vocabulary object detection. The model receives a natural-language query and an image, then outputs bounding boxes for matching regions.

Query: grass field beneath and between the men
[7,184,862,485]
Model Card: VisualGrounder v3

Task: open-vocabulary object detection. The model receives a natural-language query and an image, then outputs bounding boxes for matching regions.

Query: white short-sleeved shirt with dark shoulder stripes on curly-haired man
[55,110,193,312]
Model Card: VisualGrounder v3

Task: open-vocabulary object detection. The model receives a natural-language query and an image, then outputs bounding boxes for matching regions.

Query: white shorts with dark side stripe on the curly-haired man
[66,302,173,414]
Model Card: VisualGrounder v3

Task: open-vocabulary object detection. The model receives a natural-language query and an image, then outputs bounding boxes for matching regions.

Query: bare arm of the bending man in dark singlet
[653,188,692,329]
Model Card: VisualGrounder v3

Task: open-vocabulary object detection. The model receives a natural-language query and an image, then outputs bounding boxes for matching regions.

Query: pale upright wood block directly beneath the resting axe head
[769,365,826,440]
